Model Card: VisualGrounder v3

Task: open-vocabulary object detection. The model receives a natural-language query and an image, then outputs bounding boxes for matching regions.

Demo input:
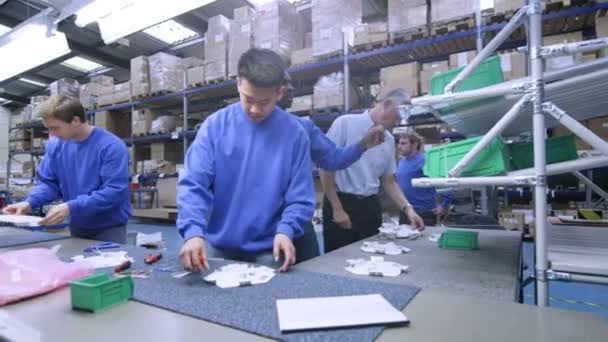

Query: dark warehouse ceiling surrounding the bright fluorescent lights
[0,0,387,106]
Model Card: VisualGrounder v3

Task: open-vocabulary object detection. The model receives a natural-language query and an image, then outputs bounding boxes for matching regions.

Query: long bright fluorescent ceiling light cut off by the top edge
[84,0,215,44]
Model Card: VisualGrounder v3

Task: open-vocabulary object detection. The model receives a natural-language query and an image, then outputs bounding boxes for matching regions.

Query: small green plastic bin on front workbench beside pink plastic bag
[69,273,133,312]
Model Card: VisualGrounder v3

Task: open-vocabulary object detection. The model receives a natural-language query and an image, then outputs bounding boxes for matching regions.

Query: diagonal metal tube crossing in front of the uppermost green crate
[445,6,528,93]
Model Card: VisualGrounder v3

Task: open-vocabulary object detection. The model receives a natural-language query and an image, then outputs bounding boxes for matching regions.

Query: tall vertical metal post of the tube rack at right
[528,0,549,307]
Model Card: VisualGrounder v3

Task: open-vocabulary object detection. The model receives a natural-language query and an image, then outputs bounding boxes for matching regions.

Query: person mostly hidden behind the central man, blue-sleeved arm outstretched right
[277,72,384,262]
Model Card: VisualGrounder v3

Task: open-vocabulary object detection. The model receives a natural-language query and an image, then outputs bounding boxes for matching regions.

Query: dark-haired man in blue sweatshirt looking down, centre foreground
[177,48,315,271]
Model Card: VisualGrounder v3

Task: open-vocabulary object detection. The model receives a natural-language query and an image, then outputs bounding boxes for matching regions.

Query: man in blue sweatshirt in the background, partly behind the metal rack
[396,133,453,226]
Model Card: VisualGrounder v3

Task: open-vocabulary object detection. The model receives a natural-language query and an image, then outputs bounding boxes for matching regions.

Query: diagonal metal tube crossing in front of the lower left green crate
[448,95,530,177]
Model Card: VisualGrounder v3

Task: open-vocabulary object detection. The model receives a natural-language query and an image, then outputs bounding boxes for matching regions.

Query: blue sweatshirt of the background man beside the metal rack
[395,153,452,212]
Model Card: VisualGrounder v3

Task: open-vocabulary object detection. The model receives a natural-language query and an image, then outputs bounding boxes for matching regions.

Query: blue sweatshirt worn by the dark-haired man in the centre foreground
[177,103,315,252]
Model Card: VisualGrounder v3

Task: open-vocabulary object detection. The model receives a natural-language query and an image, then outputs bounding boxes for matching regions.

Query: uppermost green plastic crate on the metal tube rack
[429,56,505,114]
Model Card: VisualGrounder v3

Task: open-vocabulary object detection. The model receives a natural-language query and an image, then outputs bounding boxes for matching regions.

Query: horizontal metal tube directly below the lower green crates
[412,175,536,188]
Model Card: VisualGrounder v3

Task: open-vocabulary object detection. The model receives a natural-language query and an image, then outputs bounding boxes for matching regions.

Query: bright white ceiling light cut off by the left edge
[0,10,70,81]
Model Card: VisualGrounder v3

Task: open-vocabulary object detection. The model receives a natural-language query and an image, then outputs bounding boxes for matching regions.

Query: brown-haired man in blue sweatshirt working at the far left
[3,96,131,243]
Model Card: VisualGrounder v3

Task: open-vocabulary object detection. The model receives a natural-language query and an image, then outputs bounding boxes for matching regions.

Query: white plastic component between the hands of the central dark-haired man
[204,264,275,288]
